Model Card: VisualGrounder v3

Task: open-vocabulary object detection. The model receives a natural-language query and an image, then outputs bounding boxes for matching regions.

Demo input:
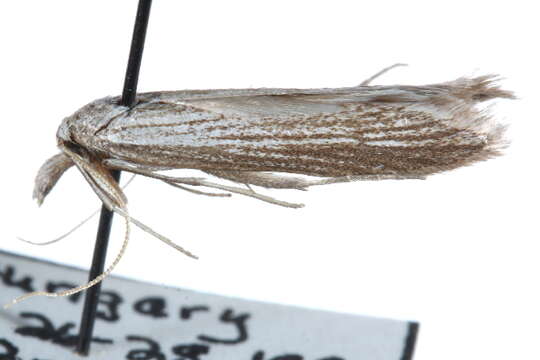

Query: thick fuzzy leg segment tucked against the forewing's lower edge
[204,170,310,191]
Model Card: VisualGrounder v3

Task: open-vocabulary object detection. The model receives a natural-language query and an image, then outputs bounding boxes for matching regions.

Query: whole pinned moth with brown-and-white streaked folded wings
[9,64,514,306]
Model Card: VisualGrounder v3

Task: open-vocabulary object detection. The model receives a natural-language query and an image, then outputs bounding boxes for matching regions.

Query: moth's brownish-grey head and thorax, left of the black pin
[56,97,128,147]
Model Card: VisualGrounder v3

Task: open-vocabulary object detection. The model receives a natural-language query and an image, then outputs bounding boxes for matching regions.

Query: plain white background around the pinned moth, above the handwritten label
[0,0,540,360]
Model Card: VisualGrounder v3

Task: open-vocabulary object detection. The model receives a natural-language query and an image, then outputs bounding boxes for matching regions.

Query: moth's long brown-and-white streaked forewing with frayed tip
[85,77,512,183]
